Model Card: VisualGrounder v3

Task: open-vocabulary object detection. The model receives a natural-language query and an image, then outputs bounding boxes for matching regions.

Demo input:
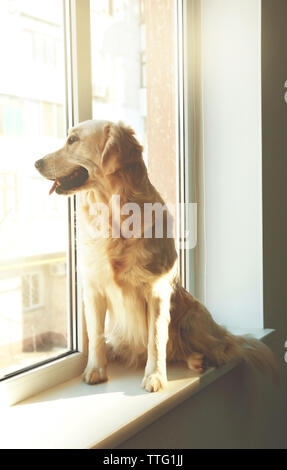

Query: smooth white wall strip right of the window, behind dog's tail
[199,0,263,328]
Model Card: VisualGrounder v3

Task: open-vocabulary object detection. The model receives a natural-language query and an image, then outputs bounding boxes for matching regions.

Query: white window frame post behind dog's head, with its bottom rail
[0,0,92,405]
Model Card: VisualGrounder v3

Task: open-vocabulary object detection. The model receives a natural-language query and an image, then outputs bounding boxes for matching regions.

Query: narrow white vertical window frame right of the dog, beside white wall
[177,0,200,296]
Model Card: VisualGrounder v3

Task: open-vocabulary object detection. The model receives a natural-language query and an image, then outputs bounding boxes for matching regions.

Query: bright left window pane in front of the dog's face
[0,0,70,378]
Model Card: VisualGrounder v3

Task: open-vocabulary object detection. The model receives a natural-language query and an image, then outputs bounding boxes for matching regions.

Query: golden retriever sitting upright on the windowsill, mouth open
[35,120,276,392]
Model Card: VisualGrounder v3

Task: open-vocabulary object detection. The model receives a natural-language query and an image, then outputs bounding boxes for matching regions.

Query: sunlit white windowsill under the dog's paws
[0,329,273,449]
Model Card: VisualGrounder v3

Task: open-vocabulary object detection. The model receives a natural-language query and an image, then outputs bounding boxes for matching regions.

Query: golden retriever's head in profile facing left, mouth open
[35,120,142,195]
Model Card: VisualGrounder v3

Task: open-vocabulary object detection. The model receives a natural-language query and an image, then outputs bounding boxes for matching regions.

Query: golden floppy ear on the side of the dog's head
[101,123,142,176]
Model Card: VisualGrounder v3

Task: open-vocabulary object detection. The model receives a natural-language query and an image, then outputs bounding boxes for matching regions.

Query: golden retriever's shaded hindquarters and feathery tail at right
[180,299,279,384]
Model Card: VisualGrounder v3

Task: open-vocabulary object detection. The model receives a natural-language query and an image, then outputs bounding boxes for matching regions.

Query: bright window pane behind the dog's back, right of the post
[90,0,177,206]
